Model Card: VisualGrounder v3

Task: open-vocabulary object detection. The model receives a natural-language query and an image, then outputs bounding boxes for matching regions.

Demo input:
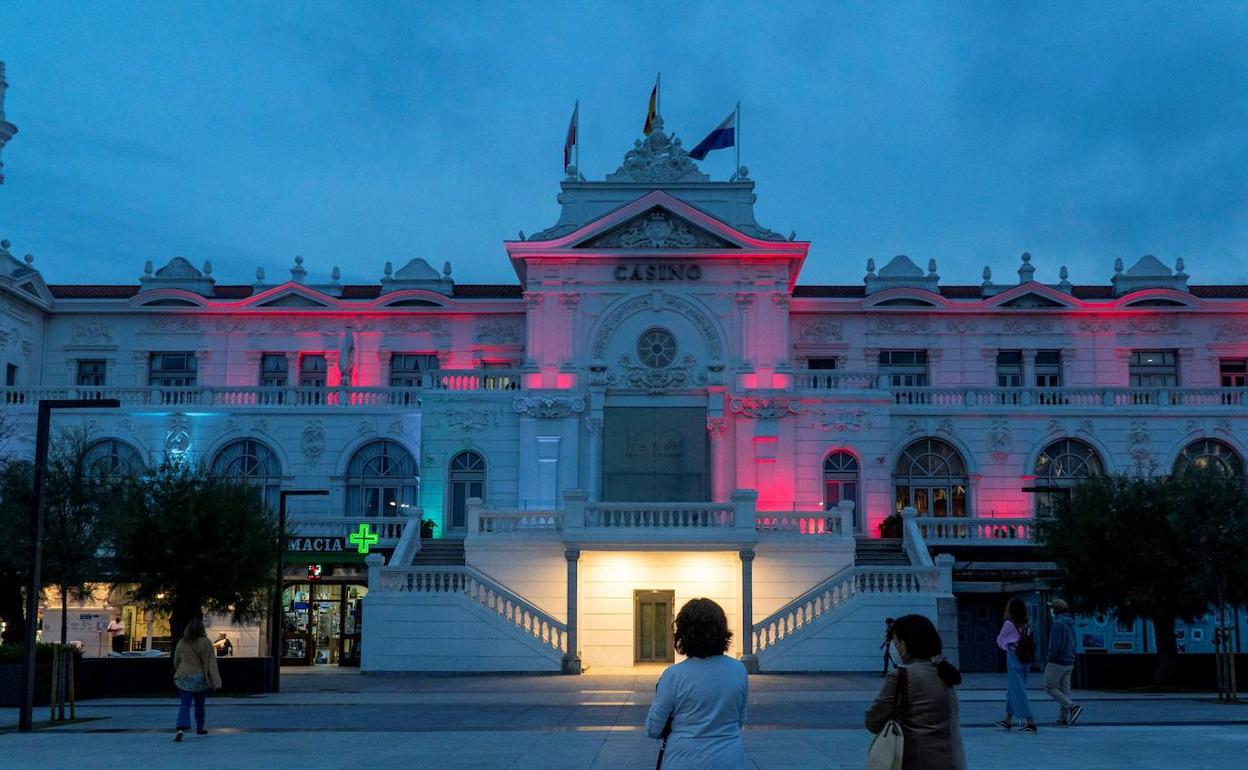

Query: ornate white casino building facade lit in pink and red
[0,111,1248,671]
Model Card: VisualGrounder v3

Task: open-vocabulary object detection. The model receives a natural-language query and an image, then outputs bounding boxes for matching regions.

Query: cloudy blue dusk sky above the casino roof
[0,1,1248,283]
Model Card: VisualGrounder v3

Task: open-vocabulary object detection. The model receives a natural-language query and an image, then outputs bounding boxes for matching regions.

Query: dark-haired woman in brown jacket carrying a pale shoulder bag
[865,615,966,770]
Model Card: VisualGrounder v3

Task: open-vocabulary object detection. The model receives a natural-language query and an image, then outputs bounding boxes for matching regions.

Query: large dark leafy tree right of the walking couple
[1038,475,1209,684]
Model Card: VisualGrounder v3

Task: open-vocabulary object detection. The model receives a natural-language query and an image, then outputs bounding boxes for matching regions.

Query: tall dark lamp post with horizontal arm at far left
[17,398,121,733]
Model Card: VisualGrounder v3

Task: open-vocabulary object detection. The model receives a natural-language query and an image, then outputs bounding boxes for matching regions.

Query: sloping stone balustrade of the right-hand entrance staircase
[751,562,953,653]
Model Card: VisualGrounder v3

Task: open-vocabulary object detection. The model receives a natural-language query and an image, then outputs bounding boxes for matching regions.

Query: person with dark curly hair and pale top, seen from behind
[645,599,749,770]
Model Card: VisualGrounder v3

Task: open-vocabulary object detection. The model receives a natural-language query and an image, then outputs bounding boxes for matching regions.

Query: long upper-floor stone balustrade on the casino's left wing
[0,369,523,408]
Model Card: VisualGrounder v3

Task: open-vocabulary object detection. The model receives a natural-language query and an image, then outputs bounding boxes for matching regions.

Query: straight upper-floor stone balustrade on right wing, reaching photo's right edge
[886,388,1248,409]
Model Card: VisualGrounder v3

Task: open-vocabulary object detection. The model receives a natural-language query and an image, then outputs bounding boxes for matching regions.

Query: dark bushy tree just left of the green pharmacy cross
[114,461,278,644]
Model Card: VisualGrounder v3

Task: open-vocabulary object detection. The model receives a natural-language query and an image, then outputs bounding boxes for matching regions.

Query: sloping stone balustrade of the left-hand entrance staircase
[368,558,568,653]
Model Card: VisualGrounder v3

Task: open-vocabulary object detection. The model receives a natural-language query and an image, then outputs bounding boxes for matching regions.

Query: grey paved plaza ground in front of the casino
[0,668,1248,770]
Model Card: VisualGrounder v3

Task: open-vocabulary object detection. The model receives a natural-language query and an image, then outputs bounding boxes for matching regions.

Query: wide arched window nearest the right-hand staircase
[892,438,968,517]
